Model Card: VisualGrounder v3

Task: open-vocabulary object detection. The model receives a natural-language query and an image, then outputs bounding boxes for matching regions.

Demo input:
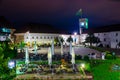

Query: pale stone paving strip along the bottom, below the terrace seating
[14,74,93,80]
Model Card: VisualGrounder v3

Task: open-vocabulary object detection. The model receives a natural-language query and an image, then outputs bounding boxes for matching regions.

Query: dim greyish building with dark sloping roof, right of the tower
[81,24,120,48]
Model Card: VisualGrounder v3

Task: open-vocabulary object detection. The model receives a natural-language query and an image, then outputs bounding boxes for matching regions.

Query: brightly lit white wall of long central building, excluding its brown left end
[24,32,79,45]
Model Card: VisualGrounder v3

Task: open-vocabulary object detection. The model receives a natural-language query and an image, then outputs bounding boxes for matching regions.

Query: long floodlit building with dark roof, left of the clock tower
[15,24,79,45]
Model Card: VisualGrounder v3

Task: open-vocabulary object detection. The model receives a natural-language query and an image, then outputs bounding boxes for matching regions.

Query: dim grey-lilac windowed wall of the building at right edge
[94,31,120,48]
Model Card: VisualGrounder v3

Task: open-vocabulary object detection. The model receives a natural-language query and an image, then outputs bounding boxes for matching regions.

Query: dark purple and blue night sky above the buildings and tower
[0,0,120,31]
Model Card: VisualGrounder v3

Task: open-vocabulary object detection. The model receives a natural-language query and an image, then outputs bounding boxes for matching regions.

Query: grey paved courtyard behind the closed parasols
[29,46,101,56]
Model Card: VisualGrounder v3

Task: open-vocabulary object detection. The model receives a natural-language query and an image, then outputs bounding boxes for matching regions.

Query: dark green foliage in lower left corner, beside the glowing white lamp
[0,47,16,80]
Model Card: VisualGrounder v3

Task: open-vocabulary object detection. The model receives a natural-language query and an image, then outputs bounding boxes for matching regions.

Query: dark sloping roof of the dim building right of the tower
[83,24,120,33]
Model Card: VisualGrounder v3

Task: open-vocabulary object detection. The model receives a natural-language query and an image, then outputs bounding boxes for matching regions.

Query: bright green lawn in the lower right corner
[91,58,120,80]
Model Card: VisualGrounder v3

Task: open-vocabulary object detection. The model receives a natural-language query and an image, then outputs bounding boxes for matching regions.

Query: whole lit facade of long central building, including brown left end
[15,32,79,44]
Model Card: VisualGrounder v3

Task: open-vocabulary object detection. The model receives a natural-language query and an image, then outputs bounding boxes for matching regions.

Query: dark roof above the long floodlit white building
[15,23,69,34]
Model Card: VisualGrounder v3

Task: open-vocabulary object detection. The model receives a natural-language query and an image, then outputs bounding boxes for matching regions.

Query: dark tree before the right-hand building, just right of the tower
[84,34,100,46]
